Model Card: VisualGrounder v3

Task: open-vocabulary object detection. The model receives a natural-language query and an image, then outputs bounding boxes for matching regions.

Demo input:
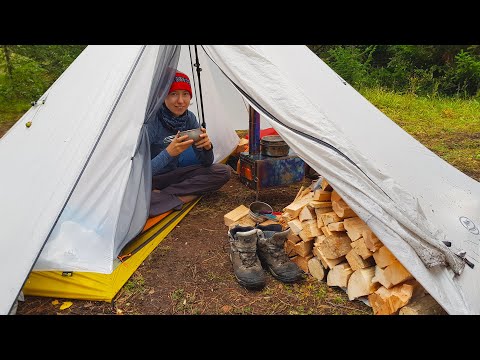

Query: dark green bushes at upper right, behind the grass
[309,45,480,99]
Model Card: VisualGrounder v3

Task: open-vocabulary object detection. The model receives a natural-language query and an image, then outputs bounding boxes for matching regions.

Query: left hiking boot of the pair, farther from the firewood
[228,225,265,290]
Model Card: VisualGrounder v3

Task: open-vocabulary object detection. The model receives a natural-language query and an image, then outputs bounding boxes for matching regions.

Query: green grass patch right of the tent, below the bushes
[361,89,480,181]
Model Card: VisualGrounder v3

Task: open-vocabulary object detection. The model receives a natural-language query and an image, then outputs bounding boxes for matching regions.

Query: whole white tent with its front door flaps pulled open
[0,45,480,314]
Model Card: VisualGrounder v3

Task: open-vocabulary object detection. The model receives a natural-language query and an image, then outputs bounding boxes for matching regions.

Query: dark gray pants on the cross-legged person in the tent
[149,164,231,217]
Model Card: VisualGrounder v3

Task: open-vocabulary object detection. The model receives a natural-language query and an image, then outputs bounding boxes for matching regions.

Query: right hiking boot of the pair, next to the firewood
[256,224,303,283]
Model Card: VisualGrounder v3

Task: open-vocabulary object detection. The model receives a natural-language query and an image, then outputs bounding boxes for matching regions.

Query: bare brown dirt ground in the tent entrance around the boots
[17,169,373,315]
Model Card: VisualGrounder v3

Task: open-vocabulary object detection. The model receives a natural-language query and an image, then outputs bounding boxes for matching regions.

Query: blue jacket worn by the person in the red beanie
[146,110,213,175]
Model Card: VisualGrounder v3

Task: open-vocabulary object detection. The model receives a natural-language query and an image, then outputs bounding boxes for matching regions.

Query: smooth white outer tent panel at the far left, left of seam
[0,46,150,314]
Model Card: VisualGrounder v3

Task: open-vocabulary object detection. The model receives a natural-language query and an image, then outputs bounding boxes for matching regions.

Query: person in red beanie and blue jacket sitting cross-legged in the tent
[147,71,231,217]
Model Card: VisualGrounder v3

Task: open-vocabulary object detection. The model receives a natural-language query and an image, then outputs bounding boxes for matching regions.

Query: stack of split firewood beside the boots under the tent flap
[280,178,444,315]
